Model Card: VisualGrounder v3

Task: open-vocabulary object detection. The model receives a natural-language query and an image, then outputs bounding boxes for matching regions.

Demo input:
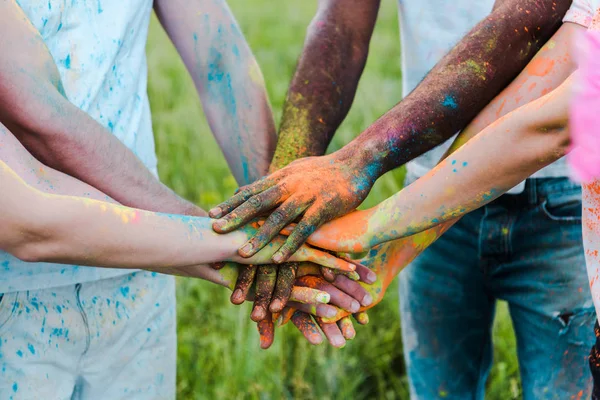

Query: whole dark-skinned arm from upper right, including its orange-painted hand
[210,0,571,262]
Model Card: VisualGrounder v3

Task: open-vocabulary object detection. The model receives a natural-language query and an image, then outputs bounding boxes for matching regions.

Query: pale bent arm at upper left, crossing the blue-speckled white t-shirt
[0,0,205,215]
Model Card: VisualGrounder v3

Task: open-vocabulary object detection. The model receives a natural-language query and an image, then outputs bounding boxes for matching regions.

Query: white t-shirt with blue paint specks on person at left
[0,0,156,293]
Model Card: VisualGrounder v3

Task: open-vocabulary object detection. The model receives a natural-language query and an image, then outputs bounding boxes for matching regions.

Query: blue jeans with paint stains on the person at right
[400,178,596,400]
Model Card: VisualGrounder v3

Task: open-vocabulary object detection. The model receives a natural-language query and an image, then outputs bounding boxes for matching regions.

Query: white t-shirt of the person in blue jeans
[399,0,568,193]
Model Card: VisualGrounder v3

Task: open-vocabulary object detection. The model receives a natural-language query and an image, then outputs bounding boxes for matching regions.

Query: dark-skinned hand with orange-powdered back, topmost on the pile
[209,152,376,263]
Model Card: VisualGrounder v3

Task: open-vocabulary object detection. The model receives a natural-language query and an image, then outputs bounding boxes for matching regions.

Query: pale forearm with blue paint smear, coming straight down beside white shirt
[154,0,276,185]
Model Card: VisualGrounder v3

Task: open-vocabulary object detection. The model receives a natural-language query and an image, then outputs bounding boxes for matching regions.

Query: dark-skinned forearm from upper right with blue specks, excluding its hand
[339,0,571,176]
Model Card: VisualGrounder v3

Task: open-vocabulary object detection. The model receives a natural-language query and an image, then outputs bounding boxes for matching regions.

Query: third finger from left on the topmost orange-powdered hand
[235,199,309,257]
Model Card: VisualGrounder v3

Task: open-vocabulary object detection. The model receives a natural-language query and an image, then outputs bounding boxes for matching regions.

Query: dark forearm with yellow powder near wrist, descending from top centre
[273,0,379,169]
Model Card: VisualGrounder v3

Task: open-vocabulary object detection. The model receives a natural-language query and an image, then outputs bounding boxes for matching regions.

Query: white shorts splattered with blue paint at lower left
[0,272,177,400]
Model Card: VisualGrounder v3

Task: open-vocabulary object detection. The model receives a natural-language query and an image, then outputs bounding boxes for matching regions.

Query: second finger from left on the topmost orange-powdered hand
[213,186,283,234]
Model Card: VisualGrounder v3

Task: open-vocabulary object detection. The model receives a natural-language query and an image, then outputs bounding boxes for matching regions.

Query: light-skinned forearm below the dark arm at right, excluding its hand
[369,78,572,242]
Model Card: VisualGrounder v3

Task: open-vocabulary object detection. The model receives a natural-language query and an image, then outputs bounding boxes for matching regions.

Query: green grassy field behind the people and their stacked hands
[148,0,520,400]
